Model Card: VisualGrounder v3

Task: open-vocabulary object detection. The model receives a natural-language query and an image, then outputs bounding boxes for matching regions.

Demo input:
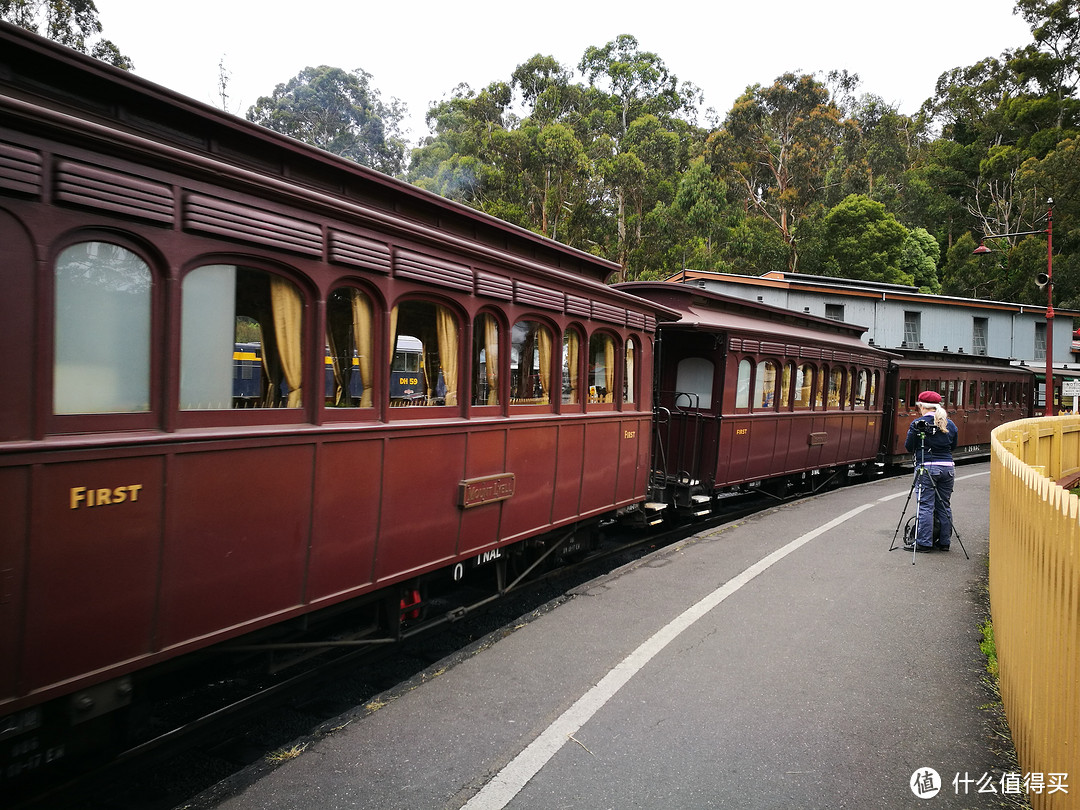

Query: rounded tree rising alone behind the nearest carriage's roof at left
[247,65,405,174]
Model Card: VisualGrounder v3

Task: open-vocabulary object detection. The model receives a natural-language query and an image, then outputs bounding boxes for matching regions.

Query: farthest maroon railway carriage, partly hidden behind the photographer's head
[882,349,1036,464]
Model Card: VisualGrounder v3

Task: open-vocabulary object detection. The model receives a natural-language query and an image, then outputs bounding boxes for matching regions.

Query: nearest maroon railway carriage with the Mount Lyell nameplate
[0,25,664,791]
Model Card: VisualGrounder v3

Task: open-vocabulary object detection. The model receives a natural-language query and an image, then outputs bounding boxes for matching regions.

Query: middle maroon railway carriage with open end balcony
[619,284,890,513]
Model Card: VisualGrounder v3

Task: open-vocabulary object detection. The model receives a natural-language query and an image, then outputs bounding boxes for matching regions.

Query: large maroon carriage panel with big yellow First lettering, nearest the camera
[23,456,164,691]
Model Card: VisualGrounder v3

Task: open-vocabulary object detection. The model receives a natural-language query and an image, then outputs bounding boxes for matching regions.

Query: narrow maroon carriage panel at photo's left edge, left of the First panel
[0,467,30,704]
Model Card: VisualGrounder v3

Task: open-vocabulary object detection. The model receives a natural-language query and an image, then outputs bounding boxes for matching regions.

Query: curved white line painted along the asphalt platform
[462,502,877,810]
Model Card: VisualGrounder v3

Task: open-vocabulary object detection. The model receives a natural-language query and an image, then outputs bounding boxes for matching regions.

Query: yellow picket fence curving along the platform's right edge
[990,416,1080,810]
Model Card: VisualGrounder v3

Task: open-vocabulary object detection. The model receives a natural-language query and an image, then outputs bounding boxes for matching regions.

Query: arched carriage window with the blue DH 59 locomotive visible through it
[390,301,458,407]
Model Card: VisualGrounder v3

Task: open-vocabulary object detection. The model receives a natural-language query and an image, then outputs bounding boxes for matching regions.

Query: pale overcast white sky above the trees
[95,0,1031,143]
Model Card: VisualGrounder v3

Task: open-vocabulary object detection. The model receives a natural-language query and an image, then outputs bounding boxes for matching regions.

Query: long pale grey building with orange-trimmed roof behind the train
[667,270,1080,369]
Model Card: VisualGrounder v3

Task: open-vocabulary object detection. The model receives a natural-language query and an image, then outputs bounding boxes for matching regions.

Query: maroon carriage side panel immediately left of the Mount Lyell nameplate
[375,438,465,582]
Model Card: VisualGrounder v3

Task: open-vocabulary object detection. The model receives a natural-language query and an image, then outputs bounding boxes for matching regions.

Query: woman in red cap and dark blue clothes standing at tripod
[904,391,958,552]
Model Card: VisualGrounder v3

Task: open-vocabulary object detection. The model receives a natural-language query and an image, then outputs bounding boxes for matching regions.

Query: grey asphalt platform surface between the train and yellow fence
[218,463,1004,810]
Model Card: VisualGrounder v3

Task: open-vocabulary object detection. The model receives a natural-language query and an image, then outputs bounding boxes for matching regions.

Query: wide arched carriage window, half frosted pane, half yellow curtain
[180,265,303,410]
